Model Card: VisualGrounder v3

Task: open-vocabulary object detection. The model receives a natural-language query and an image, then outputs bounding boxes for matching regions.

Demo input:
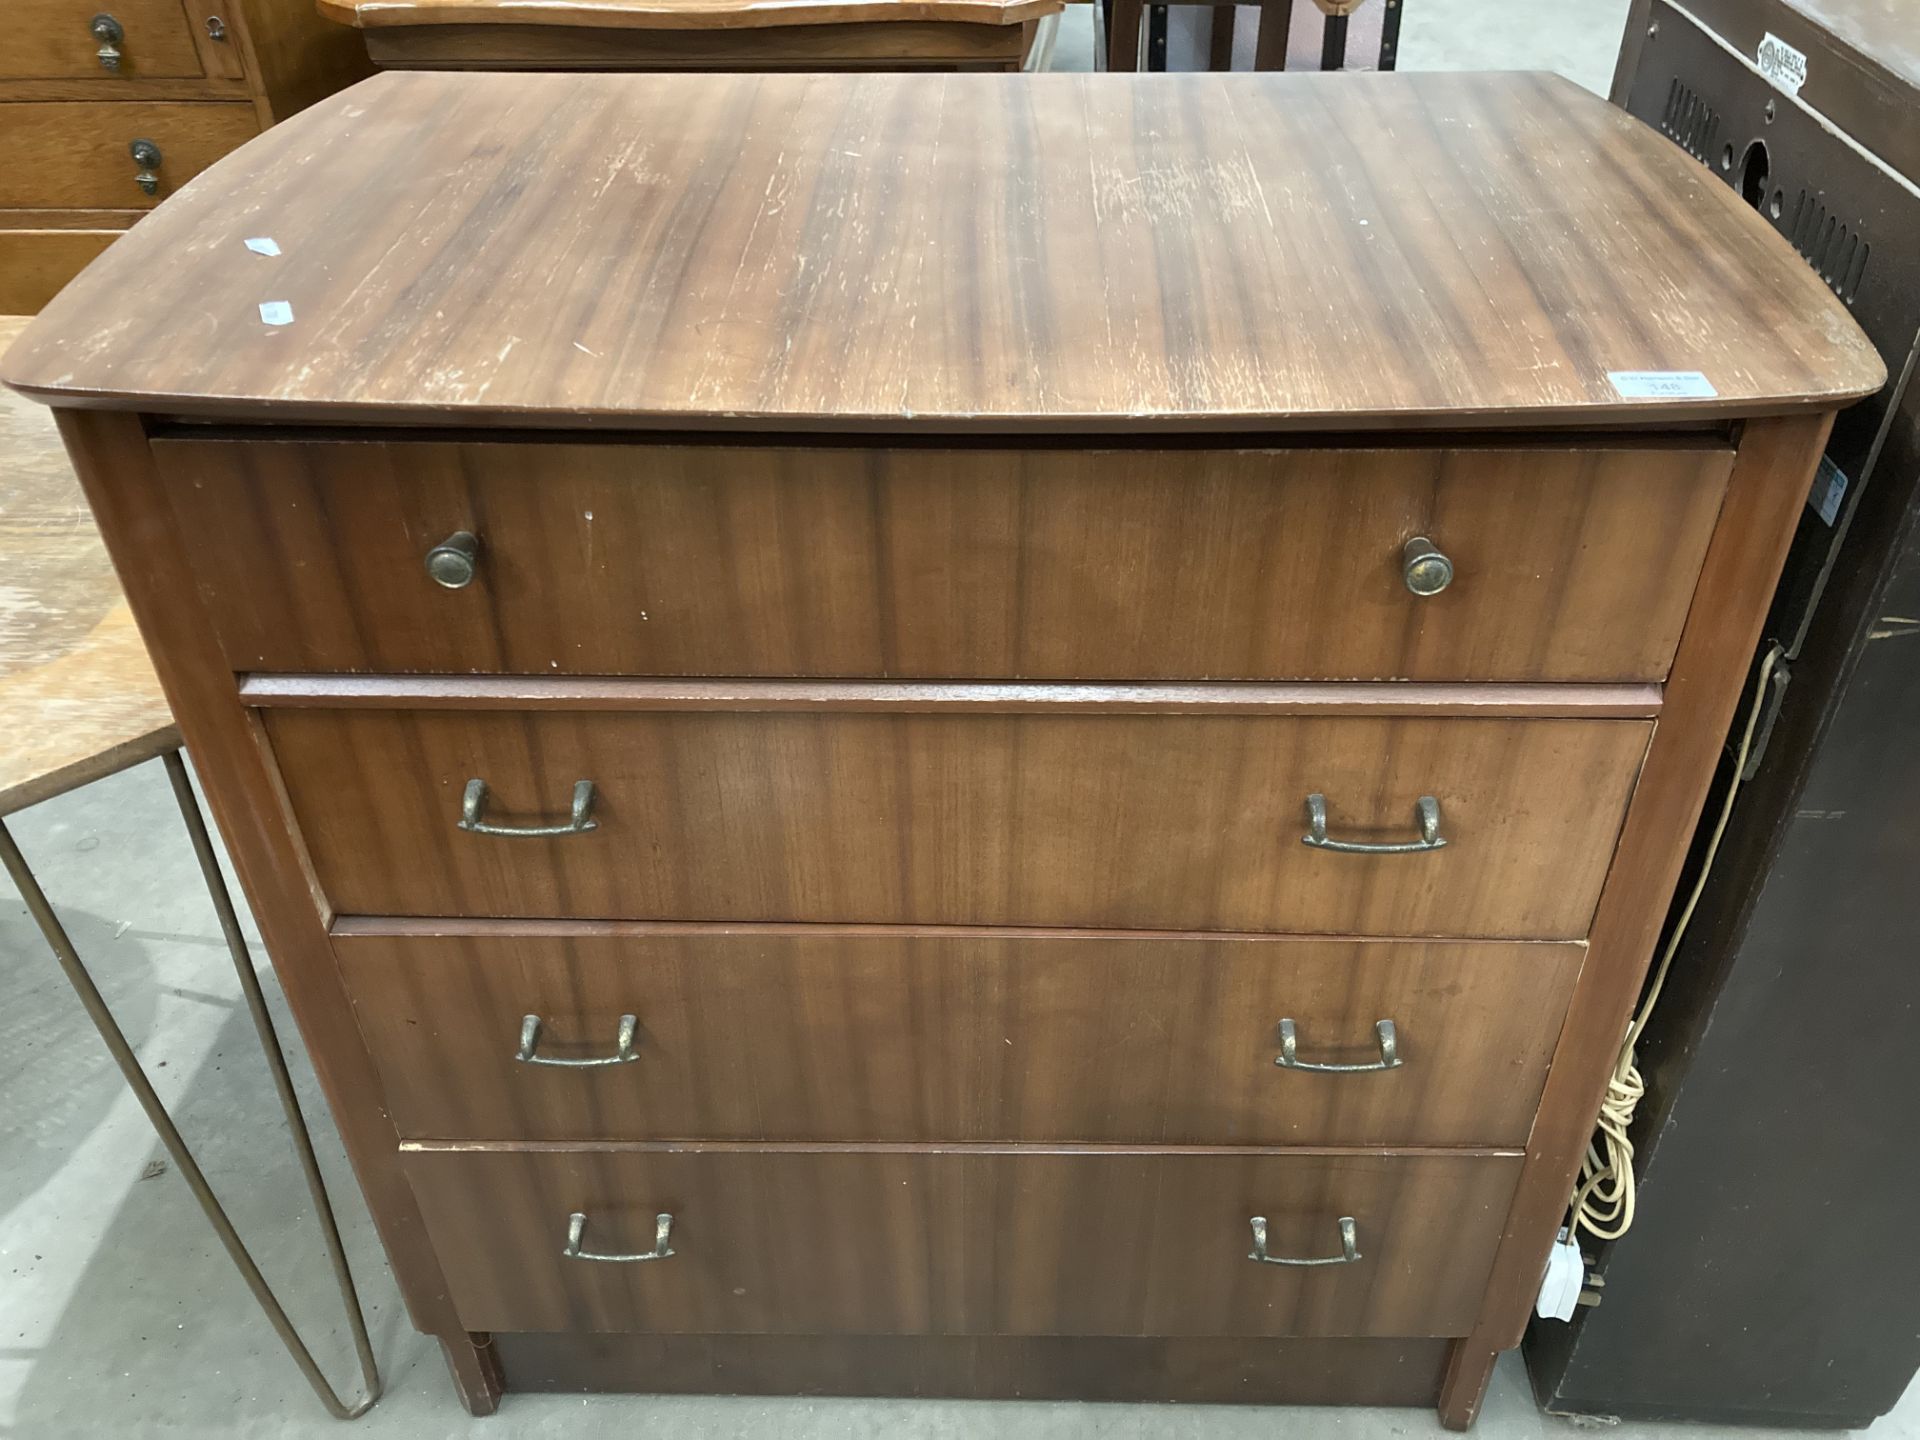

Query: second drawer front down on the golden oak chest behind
[0,102,259,209]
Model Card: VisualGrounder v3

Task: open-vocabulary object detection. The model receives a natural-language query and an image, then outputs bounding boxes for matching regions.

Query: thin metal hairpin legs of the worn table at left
[0,749,380,1421]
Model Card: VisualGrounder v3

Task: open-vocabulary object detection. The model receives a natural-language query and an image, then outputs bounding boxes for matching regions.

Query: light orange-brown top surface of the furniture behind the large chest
[319,0,1064,31]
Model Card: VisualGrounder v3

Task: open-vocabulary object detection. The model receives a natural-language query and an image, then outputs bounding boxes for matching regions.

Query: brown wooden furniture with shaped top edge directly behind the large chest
[319,0,1067,71]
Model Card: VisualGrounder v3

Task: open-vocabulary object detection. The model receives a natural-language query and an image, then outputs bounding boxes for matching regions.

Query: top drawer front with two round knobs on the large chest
[154,440,1730,682]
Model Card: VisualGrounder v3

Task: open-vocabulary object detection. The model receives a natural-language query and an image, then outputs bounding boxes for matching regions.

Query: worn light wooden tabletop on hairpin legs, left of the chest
[0,315,180,814]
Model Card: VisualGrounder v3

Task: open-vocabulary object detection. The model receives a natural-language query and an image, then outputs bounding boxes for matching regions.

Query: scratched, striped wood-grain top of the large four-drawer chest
[0,73,1885,432]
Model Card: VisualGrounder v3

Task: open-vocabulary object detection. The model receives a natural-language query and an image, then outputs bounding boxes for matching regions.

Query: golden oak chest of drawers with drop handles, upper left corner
[0,0,371,315]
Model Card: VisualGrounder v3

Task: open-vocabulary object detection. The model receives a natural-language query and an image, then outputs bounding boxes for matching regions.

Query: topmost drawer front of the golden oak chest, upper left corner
[0,0,202,81]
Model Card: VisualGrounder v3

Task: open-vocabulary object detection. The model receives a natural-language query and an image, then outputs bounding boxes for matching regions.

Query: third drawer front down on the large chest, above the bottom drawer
[334,927,1582,1146]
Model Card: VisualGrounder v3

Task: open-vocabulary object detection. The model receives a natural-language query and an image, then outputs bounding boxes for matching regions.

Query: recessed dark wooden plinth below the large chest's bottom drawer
[493,1331,1448,1405]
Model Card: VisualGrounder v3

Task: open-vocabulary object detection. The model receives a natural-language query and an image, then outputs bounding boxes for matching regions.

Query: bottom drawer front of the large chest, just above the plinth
[403,1146,1521,1336]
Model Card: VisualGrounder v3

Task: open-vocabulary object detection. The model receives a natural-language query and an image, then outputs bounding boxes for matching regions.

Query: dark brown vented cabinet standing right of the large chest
[1526,0,1920,1427]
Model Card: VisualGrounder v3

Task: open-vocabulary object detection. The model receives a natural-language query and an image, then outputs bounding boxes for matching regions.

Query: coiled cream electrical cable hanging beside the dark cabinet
[1567,645,1786,1240]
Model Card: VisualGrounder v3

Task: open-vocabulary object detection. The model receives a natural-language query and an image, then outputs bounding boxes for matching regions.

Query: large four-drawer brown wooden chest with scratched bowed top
[6,75,1884,1425]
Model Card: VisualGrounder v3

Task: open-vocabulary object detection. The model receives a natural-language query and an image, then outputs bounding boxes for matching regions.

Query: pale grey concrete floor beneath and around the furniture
[0,0,1920,1440]
